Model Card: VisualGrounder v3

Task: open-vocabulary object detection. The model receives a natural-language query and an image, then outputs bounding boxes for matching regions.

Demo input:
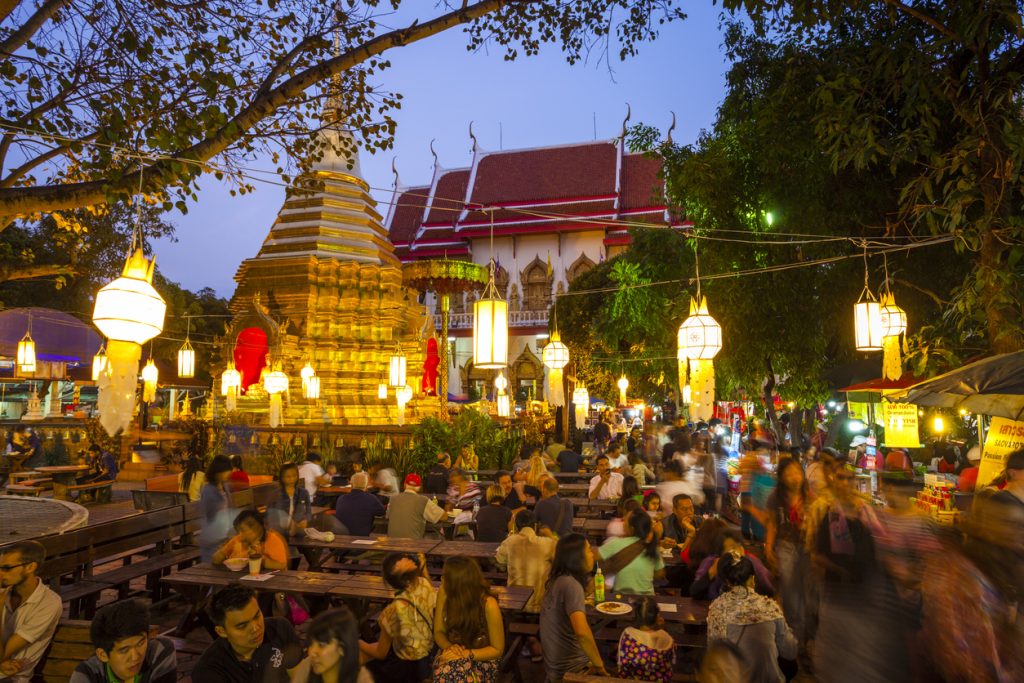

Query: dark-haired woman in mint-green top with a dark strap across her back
[597,509,665,595]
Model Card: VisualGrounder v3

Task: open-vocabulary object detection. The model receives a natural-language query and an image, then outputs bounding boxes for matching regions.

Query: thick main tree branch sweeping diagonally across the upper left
[0,0,516,216]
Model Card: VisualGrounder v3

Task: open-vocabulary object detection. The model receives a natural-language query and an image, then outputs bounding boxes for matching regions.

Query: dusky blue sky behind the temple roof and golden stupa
[156,0,727,297]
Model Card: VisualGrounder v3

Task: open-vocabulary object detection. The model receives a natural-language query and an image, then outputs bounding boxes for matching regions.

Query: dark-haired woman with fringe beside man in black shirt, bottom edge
[291,607,374,683]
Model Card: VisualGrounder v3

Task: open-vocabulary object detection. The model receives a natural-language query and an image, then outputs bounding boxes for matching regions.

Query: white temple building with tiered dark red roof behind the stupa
[386,127,673,400]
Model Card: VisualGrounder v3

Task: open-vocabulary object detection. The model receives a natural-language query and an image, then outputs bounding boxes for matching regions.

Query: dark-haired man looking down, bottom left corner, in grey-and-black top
[70,600,178,683]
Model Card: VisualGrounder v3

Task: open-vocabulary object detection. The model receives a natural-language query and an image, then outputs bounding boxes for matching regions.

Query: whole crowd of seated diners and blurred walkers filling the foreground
[0,409,1024,683]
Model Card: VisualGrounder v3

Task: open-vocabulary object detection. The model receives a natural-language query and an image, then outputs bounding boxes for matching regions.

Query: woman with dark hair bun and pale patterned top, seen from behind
[708,553,797,683]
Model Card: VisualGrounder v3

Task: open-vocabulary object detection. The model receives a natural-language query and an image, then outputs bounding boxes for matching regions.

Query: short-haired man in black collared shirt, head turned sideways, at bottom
[191,586,302,683]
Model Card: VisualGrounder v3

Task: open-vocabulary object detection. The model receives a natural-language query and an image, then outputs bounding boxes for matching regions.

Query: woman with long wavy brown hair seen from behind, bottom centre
[433,557,505,683]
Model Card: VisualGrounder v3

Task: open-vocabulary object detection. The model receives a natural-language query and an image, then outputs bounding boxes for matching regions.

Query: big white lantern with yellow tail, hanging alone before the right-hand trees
[676,297,722,420]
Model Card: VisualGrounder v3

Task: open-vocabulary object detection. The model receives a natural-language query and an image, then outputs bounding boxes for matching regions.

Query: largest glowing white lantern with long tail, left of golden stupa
[92,249,167,436]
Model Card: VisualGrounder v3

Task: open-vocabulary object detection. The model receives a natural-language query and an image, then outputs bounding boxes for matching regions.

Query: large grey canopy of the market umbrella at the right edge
[887,351,1024,420]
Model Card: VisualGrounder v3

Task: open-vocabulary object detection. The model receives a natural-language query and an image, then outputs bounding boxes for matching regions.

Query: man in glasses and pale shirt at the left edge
[0,541,62,683]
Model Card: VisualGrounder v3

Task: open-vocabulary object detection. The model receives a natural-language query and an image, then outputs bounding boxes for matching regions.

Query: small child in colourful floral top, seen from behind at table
[618,597,676,683]
